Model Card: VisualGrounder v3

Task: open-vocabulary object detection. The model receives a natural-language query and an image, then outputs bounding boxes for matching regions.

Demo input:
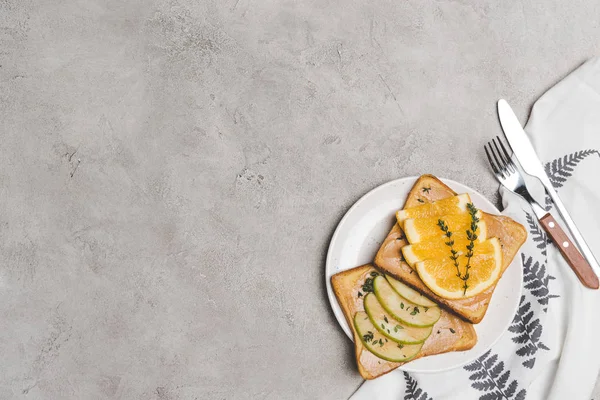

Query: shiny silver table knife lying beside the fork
[498,99,600,276]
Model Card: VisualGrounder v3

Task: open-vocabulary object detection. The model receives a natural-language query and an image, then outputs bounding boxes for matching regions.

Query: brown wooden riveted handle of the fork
[540,213,600,289]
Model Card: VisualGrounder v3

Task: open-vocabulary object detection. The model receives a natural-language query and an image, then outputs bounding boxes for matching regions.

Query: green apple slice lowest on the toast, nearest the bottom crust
[354,311,423,362]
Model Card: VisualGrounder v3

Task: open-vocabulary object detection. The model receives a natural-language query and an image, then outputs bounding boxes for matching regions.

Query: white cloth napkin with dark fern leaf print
[351,58,600,400]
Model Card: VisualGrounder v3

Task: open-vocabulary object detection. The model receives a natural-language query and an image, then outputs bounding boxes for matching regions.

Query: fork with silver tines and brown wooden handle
[484,136,600,289]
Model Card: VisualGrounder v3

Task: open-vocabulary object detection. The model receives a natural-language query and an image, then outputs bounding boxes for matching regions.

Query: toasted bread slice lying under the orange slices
[375,175,527,324]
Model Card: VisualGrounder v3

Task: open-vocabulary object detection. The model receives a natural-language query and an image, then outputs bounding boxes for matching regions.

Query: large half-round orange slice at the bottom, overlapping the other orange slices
[415,238,502,299]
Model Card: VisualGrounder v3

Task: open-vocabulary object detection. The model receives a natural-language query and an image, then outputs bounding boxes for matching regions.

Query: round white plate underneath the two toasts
[325,177,523,372]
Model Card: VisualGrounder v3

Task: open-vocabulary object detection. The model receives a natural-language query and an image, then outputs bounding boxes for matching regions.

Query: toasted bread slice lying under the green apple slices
[331,264,477,379]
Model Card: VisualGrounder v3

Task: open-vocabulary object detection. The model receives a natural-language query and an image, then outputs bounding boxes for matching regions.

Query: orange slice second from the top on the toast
[404,210,487,244]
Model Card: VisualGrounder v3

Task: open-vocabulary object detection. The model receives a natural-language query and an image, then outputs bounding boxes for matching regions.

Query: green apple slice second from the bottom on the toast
[364,293,433,344]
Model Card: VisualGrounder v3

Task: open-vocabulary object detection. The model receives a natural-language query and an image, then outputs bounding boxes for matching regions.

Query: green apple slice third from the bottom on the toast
[373,275,441,327]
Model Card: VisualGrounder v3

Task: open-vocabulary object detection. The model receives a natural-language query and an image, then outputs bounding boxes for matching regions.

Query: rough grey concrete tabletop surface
[0,0,600,400]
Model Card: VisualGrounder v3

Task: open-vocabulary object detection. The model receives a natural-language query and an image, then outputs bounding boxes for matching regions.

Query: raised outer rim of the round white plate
[325,175,523,374]
